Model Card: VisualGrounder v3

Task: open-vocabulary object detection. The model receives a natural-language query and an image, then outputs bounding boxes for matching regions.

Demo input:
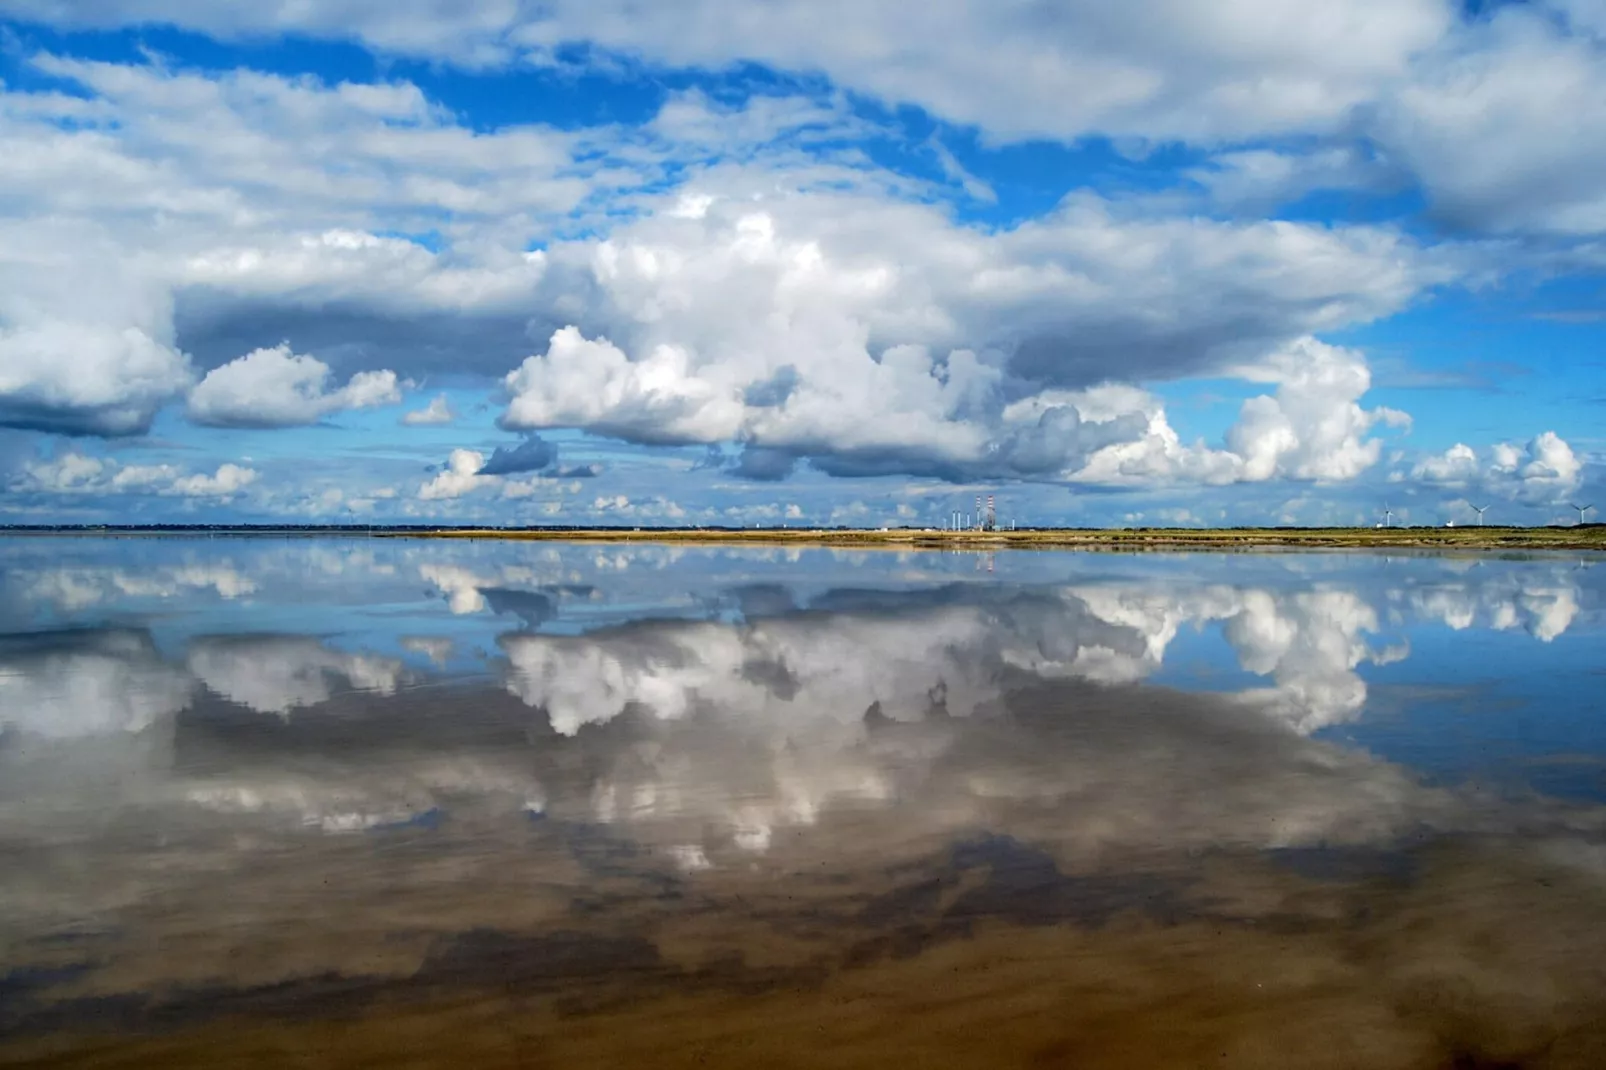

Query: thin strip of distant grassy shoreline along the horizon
[0,524,1606,551]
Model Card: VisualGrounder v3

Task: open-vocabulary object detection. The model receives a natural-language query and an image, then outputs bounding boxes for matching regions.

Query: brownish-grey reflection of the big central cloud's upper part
[510,645,1460,871]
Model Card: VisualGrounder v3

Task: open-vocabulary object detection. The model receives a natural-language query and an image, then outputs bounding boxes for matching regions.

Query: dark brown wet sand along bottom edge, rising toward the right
[0,848,1606,1068]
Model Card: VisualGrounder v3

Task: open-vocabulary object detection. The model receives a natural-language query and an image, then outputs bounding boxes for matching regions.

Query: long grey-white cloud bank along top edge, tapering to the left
[0,0,1452,140]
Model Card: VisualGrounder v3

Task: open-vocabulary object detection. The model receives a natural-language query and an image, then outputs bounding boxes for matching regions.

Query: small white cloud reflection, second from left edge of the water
[188,636,403,713]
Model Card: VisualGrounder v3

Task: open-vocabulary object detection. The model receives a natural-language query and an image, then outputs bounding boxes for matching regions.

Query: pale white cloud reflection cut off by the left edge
[0,633,191,739]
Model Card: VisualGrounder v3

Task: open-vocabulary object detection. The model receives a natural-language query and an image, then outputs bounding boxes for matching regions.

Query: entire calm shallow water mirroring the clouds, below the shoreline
[0,538,1606,1067]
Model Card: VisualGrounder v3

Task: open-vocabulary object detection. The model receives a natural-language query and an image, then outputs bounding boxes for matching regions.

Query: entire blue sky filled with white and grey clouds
[0,0,1606,527]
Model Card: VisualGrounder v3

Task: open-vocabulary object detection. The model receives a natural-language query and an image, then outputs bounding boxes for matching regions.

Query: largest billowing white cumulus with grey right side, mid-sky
[501,194,1439,479]
